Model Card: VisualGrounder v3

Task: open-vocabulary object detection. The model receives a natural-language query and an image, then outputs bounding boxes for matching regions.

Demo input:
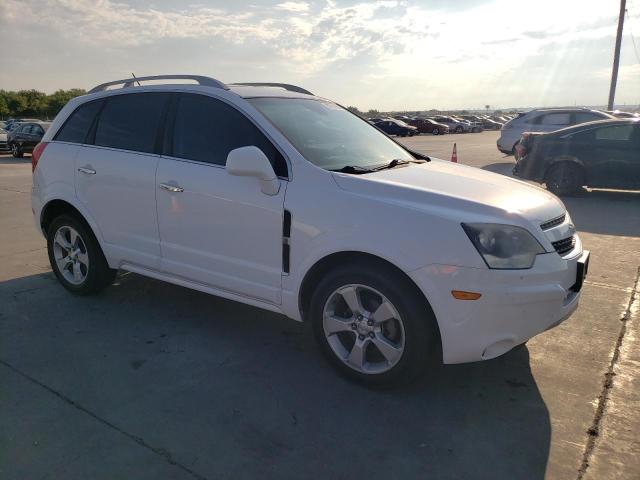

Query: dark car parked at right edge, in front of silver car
[513,119,640,195]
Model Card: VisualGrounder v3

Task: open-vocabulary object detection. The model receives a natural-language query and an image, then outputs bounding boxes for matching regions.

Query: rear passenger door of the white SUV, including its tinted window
[76,93,169,269]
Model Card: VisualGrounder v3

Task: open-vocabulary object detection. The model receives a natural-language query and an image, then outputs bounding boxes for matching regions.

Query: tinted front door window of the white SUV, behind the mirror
[172,94,287,177]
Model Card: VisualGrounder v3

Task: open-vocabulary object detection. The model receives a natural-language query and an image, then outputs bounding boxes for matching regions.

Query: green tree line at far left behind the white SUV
[0,88,86,120]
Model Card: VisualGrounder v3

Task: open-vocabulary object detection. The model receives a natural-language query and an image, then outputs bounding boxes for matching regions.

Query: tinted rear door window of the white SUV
[95,93,167,153]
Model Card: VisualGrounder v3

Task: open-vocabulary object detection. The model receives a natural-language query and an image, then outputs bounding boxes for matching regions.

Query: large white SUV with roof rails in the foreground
[32,76,588,384]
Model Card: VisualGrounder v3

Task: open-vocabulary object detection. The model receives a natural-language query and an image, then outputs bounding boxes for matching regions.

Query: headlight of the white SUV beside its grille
[462,223,545,269]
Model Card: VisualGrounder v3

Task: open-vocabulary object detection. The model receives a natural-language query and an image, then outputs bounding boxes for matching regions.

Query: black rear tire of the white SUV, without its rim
[47,214,117,295]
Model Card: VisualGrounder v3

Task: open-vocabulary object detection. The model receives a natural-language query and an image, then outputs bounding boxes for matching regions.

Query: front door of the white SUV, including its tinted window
[156,94,287,304]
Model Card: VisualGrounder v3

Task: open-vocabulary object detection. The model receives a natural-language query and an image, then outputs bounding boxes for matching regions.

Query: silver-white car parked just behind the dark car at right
[497,108,615,155]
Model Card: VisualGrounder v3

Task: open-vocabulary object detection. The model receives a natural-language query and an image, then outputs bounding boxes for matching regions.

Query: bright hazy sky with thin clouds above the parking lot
[0,0,640,110]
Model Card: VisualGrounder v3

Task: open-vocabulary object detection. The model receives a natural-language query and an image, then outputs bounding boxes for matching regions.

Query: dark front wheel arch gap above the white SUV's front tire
[298,250,442,348]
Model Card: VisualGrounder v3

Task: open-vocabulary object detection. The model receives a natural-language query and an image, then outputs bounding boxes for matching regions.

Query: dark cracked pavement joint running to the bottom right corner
[576,267,640,480]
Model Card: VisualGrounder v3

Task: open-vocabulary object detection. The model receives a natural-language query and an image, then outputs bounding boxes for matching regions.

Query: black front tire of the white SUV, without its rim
[306,263,440,387]
